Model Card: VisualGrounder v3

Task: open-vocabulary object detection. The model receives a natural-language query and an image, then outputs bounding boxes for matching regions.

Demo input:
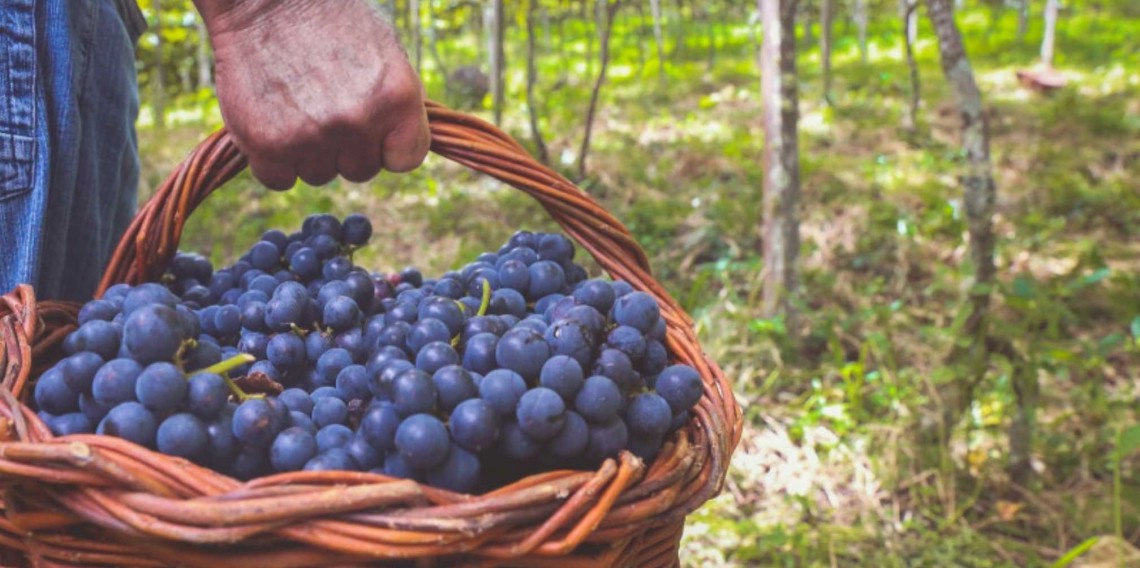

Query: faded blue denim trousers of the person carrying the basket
[0,0,140,300]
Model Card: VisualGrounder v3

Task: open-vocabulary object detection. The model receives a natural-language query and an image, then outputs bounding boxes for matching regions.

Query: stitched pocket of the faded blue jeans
[0,0,35,201]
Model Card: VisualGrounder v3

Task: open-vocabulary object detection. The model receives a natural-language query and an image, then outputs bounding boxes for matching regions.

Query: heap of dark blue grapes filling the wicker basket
[34,214,702,492]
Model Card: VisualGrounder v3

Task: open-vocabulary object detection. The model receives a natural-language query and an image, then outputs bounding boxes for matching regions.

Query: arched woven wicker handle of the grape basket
[96,100,692,326]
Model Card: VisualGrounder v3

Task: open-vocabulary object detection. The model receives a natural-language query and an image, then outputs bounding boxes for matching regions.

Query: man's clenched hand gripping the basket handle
[194,0,431,189]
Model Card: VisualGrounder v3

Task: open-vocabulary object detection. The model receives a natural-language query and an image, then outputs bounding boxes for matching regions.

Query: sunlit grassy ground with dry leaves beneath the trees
[140,6,1140,567]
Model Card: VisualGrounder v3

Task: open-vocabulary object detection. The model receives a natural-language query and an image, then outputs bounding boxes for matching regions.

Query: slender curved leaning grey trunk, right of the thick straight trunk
[920,0,995,456]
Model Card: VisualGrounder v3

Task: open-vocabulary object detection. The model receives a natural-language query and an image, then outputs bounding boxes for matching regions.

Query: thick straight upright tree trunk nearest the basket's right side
[758,0,799,323]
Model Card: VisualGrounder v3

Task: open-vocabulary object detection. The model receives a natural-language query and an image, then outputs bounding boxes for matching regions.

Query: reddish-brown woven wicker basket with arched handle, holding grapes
[0,103,741,568]
